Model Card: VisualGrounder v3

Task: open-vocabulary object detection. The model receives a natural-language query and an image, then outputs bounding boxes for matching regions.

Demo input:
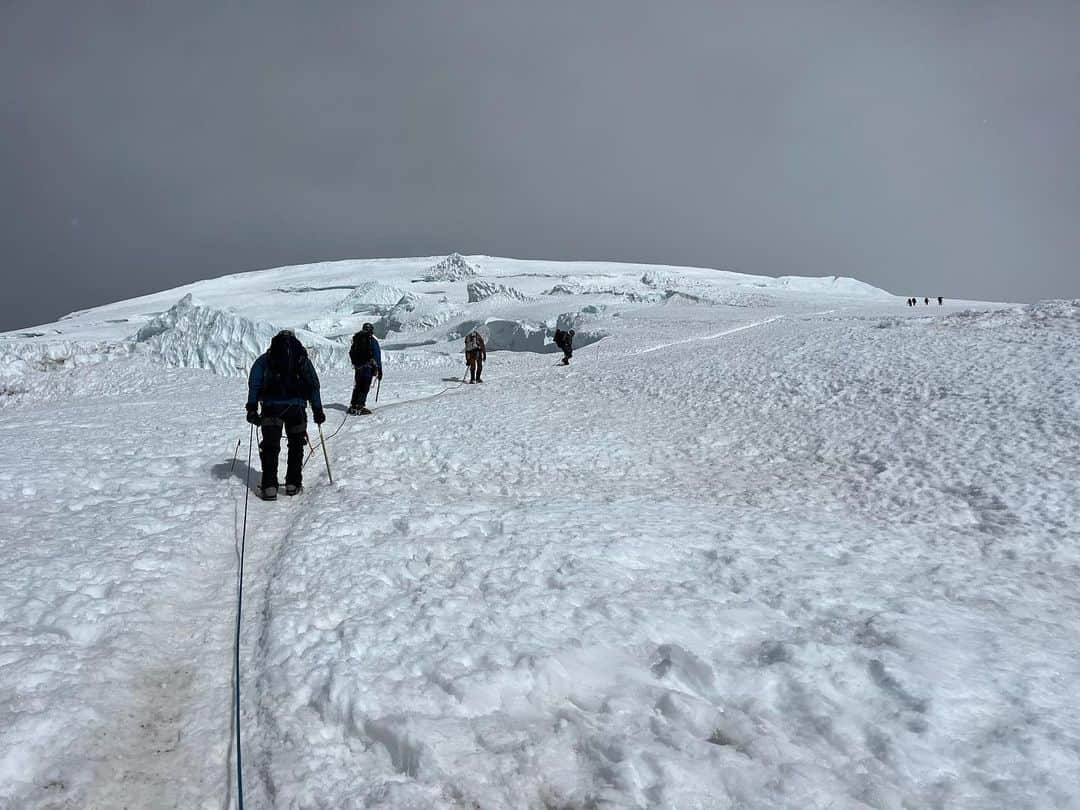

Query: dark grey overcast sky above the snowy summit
[0,0,1080,329]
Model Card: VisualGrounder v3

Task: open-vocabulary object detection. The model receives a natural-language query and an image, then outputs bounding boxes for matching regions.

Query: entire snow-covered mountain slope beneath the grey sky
[0,256,1080,810]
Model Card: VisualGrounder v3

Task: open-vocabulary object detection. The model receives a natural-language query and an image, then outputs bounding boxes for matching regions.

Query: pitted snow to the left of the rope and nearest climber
[0,366,247,808]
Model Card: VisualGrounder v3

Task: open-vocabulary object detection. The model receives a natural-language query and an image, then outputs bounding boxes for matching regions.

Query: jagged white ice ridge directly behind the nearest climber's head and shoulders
[131,293,346,377]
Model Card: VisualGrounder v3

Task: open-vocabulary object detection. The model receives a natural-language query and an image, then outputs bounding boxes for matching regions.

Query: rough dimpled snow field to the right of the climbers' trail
[238,306,1080,807]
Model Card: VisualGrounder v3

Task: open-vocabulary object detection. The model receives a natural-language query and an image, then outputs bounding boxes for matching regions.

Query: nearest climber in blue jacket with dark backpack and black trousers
[246,329,326,501]
